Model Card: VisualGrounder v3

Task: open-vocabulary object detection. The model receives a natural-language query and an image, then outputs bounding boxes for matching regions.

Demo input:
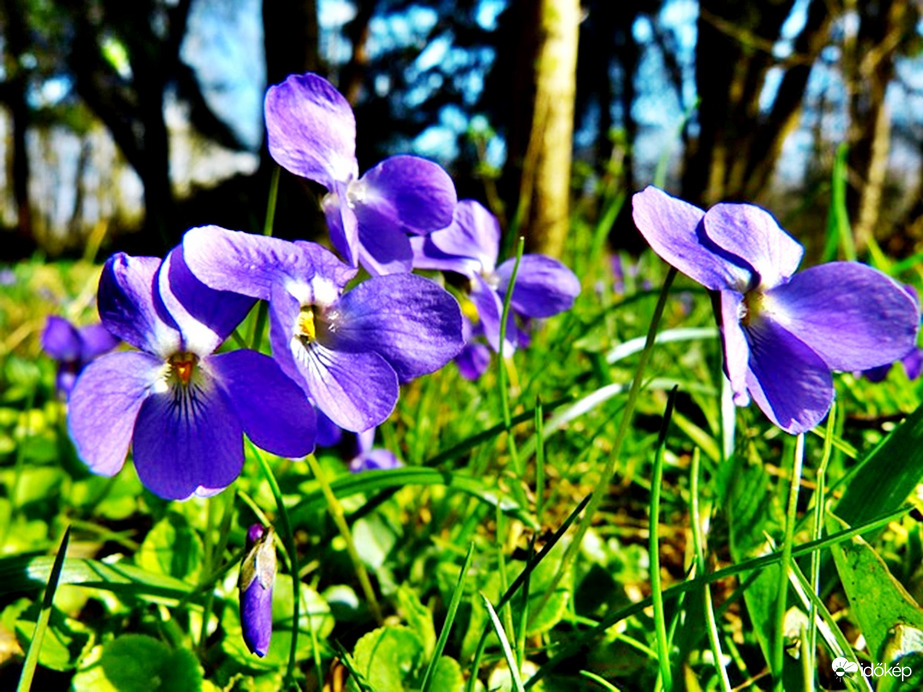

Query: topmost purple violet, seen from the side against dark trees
[265,73,457,274]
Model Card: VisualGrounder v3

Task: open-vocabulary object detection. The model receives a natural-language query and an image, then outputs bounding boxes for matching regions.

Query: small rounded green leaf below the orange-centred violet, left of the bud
[136,512,204,583]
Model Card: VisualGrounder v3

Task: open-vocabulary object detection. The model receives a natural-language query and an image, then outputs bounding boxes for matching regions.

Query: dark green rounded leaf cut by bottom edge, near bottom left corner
[73,634,203,692]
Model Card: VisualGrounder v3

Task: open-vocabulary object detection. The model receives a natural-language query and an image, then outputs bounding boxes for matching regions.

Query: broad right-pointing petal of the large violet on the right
[763,262,920,371]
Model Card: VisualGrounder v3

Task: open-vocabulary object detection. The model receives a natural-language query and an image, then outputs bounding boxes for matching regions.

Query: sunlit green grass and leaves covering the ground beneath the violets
[0,184,923,692]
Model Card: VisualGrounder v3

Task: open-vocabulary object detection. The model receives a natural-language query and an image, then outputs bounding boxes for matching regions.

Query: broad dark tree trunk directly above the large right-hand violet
[682,0,831,206]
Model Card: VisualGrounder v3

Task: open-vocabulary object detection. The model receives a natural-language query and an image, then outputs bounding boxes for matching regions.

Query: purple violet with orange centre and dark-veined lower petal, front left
[68,249,314,499]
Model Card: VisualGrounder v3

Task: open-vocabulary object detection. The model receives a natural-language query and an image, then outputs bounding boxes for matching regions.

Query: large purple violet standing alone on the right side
[632,187,920,434]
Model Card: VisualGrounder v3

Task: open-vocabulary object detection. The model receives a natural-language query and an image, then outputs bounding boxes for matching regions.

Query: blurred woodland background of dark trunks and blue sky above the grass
[0,0,923,262]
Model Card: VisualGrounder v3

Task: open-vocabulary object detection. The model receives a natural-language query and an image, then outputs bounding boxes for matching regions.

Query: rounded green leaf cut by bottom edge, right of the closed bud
[349,626,423,692]
